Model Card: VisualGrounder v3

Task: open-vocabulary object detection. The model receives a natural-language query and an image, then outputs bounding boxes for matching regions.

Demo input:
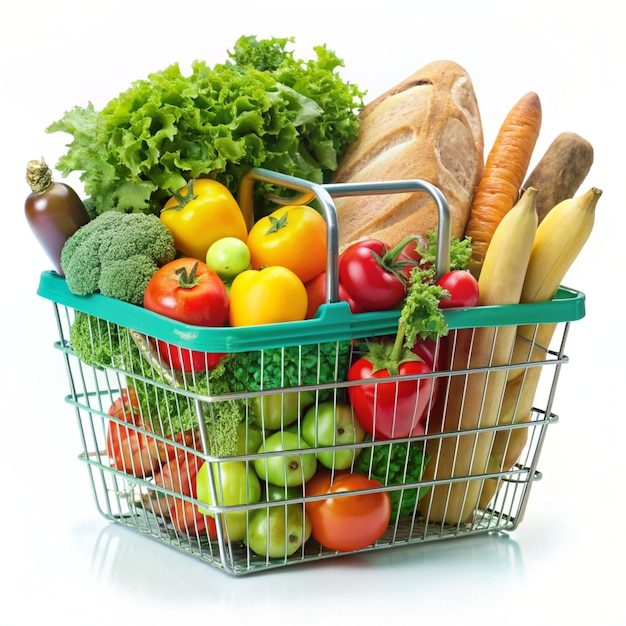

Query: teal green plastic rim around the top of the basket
[37,271,585,352]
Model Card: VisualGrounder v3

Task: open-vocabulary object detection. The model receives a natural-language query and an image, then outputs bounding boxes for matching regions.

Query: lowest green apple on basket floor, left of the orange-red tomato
[245,504,312,559]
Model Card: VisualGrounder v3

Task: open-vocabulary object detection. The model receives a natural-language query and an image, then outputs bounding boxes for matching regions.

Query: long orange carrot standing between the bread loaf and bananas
[465,91,541,278]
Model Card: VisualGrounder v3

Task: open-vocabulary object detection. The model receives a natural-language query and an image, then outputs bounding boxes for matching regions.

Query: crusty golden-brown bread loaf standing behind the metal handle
[333,60,484,250]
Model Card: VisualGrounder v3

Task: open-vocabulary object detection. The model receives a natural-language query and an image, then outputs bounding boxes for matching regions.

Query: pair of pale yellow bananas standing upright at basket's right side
[418,187,602,524]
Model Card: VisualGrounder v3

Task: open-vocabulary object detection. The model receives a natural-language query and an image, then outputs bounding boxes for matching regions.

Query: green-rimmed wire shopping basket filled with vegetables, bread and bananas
[29,37,601,571]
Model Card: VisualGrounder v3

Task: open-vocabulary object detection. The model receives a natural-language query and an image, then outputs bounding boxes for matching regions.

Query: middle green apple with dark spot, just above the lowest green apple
[253,430,317,487]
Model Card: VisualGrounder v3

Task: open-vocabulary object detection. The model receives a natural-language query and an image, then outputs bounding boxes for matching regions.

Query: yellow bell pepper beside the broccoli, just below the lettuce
[160,178,248,262]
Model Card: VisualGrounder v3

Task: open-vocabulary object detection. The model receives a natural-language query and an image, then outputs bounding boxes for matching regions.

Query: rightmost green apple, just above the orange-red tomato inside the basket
[301,402,365,470]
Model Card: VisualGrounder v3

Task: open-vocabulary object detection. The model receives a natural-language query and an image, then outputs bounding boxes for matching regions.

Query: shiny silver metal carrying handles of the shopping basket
[238,168,450,304]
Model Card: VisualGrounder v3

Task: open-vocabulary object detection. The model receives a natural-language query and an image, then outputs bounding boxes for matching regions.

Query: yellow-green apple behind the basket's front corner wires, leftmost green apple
[196,461,261,541]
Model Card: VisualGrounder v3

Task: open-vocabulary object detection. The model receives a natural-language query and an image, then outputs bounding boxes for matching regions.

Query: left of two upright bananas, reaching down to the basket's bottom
[419,187,538,524]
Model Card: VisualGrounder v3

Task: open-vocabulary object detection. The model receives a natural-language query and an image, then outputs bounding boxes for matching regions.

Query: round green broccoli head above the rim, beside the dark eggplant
[61,211,176,306]
